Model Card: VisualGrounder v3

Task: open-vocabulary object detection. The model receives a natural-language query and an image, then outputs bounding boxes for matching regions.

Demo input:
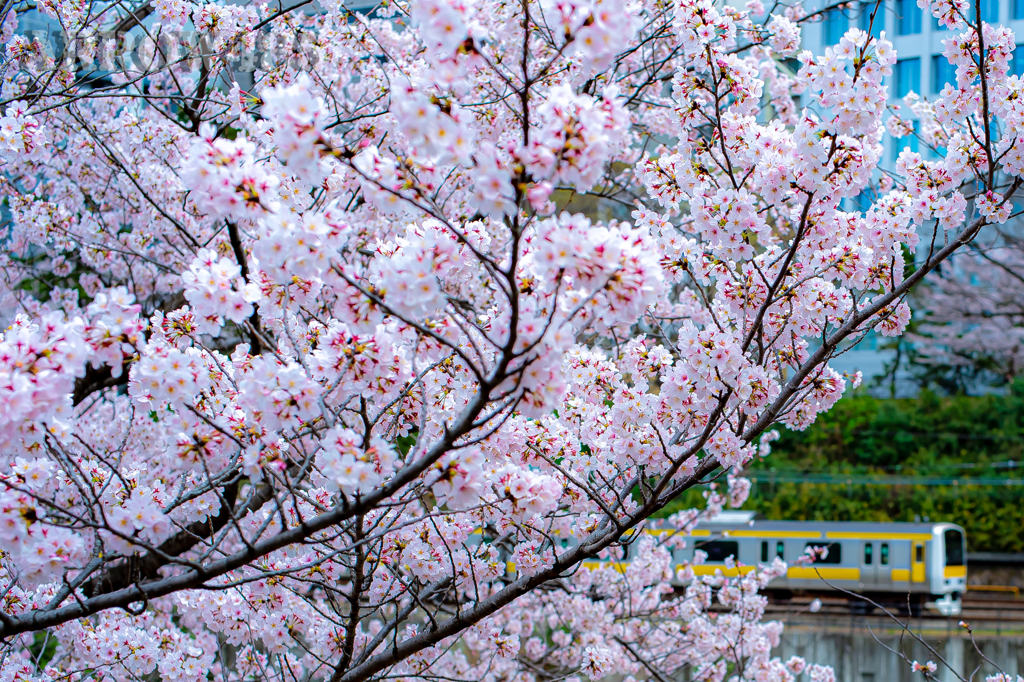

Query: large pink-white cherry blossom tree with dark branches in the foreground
[0,0,1024,682]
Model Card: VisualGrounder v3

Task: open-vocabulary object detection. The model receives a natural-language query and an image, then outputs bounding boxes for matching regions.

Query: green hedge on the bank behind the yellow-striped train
[655,381,1024,552]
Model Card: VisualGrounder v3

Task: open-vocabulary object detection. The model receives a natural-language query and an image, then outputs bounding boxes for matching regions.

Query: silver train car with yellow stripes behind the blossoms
[671,512,967,615]
